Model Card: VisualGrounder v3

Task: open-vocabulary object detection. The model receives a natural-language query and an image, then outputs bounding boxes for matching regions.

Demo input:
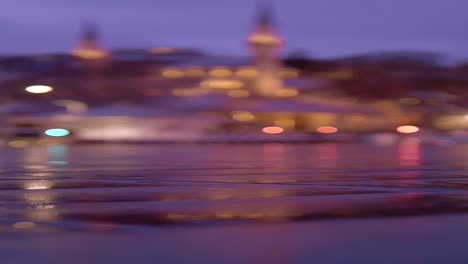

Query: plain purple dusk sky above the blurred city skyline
[0,0,468,58]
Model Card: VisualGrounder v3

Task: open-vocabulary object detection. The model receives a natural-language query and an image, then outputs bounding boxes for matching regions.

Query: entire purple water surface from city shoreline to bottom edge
[0,140,468,264]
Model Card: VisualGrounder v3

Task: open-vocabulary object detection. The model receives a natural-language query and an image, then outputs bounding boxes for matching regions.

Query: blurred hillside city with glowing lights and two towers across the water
[0,3,468,144]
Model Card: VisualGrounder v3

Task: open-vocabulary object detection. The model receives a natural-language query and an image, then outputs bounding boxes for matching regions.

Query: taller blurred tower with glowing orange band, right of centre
[248,3,284,97]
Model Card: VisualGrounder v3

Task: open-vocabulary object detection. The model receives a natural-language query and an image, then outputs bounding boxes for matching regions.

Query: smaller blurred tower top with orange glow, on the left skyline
[72,23,109,60]
